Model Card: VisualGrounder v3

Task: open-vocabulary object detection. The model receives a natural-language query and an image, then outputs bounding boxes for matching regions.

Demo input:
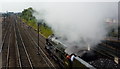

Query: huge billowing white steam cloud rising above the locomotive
[34,2,118,50]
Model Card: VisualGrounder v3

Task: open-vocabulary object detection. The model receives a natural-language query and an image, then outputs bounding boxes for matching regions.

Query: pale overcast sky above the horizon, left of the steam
[0,0,119,12]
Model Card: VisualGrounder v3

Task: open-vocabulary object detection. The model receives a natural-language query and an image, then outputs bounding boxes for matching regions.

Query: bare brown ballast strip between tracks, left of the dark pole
[17,19,45,68]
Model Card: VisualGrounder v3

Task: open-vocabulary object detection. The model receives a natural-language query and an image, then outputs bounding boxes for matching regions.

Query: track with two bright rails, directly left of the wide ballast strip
[15,18,33,69]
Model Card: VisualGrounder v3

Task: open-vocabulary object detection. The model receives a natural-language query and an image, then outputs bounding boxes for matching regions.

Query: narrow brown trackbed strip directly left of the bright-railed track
[6,20,18,68]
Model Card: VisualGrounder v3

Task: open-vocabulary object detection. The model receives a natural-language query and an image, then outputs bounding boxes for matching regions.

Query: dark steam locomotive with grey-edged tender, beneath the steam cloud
[45,35,95,69]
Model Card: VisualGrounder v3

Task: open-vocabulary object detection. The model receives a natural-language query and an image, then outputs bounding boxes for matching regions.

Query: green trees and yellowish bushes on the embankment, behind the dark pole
[20,7,53,37]
